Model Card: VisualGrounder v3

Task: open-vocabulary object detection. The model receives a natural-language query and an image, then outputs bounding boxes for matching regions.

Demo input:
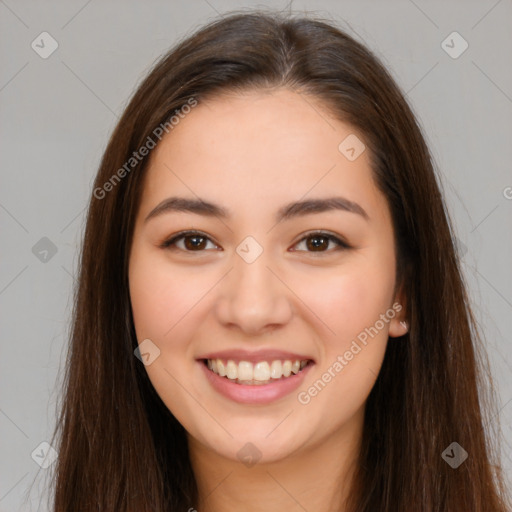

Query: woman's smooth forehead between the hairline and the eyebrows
[143,89,383,222]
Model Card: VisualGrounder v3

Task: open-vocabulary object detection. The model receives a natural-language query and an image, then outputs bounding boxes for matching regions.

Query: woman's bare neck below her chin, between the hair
[188,411,362,512]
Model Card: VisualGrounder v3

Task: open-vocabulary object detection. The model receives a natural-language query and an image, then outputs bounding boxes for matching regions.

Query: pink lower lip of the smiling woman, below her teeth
[198,360,313,404]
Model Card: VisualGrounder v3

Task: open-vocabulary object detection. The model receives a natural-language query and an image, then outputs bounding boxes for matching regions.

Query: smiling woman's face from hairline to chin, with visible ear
[129,89,405,462]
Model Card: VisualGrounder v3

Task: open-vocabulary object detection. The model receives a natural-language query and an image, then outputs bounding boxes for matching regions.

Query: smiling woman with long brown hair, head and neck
[48,12,506,512]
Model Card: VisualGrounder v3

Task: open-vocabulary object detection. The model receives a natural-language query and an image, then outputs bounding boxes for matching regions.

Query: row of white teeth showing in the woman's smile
[207,359,308,384]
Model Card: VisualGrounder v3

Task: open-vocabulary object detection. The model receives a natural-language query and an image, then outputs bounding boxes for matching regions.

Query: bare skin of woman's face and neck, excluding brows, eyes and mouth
[129,89,406,512]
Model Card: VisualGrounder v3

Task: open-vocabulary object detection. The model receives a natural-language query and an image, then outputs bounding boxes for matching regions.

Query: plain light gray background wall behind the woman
[0,0,512,511]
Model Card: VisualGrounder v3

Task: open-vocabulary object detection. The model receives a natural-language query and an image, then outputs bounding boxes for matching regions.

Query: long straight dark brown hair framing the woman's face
[46,11,508,512]
